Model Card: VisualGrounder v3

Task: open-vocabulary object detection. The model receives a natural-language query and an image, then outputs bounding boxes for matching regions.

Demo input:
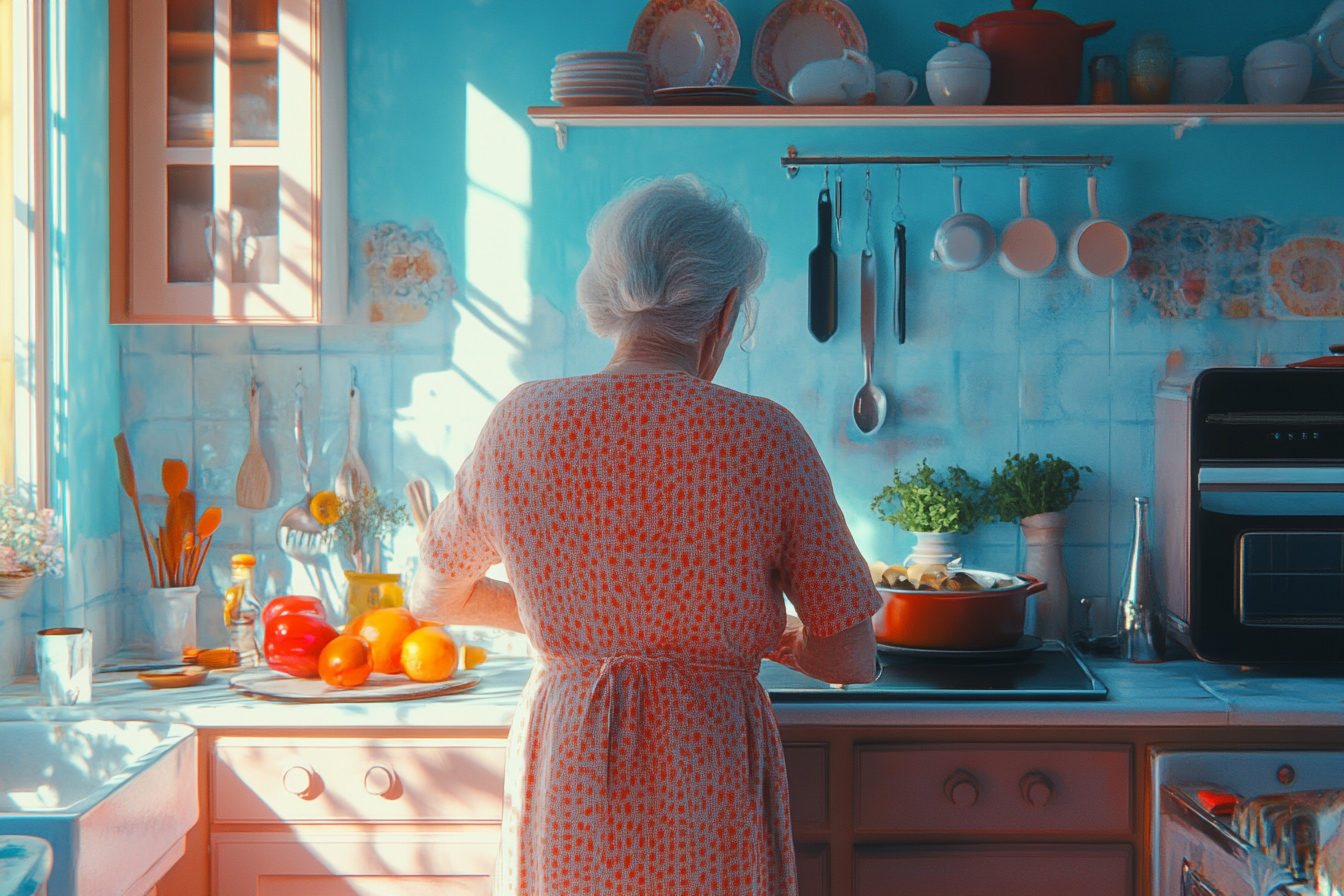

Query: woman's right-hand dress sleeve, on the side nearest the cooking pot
[775,408,882,638]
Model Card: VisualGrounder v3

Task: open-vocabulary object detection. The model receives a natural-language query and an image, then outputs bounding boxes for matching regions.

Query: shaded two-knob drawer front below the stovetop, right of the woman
[855,744,1132,838]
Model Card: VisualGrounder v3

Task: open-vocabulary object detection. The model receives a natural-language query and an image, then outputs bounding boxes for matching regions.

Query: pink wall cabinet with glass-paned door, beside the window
[113,0,347,324]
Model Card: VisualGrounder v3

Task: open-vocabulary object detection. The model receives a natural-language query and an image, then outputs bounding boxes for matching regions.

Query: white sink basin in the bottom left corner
[0,720,199,896]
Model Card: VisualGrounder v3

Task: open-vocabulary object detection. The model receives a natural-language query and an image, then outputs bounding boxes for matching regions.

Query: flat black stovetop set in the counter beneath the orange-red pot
[761,641,1106,703]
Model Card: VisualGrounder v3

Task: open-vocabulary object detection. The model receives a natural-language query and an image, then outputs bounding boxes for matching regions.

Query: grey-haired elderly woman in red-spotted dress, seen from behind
[413,177,880,896]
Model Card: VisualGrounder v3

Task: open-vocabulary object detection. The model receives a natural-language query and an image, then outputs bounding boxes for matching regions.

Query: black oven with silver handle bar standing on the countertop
[1154,368,1344,665]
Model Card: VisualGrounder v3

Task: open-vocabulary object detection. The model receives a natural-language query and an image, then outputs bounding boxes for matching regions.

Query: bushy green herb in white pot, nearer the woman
[872,458,989,566]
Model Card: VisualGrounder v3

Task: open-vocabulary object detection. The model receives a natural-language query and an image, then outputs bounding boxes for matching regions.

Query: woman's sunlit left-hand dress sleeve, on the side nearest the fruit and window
[421,445,500,582]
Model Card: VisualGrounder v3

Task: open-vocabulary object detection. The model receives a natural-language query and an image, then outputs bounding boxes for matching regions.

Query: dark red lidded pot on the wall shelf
[933,0,1116,106]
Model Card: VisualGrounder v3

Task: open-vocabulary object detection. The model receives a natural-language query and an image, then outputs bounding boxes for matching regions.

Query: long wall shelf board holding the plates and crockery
[527,103,1344,148]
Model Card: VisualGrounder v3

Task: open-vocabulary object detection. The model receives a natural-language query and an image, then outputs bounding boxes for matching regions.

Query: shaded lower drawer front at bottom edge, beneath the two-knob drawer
[853,845,1133,896]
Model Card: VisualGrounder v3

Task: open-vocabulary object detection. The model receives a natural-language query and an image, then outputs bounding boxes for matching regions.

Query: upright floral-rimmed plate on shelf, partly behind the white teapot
[751,0,868,102]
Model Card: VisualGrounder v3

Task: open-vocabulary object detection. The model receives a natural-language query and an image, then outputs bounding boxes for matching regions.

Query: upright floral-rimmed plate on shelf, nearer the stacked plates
[629,0,742,89]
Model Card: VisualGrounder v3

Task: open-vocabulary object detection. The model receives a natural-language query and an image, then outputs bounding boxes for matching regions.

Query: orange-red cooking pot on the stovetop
[872,570,1046,650]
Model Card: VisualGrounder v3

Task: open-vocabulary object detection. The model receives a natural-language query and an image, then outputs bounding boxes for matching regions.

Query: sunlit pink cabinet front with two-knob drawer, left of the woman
[208,735,505,896]
